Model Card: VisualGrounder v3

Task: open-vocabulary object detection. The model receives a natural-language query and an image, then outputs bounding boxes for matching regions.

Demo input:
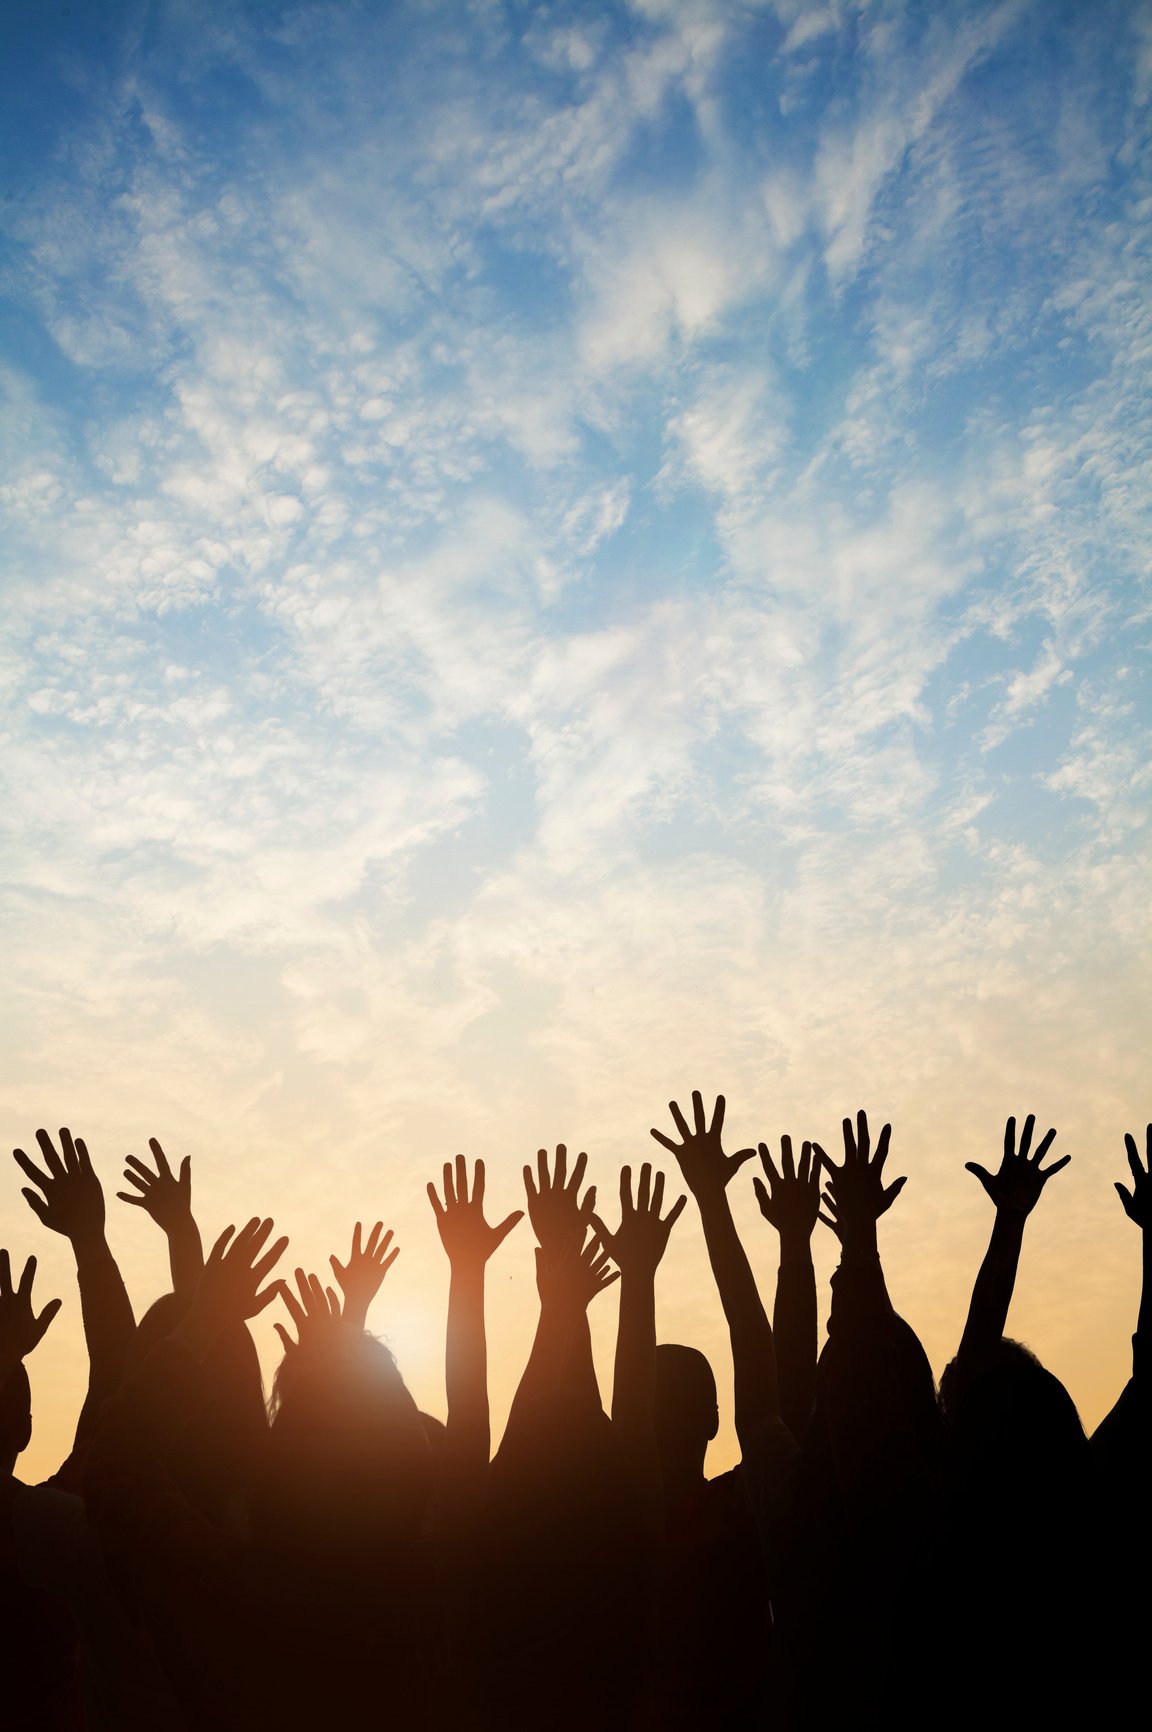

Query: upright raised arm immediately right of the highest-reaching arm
[752,1136,819,1438]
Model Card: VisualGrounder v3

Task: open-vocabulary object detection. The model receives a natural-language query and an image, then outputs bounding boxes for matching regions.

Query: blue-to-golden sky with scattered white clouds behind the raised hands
[0,0,1152,1477]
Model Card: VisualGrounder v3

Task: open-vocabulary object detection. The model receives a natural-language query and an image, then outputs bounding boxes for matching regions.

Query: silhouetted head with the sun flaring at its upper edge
[256,1328,431,1555]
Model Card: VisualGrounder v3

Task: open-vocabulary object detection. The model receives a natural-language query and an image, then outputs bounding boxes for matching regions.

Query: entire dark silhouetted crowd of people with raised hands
[0,1093,1152,1732]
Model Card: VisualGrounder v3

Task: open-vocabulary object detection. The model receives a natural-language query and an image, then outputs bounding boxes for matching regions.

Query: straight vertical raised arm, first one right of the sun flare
[428,1155,523,1472]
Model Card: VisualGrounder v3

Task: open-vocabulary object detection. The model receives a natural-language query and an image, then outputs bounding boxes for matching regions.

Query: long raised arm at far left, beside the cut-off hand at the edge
[12,1129,135,1450]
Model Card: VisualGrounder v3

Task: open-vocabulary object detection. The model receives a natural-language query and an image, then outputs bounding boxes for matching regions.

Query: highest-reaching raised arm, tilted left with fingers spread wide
[651,1091,780,1455]
